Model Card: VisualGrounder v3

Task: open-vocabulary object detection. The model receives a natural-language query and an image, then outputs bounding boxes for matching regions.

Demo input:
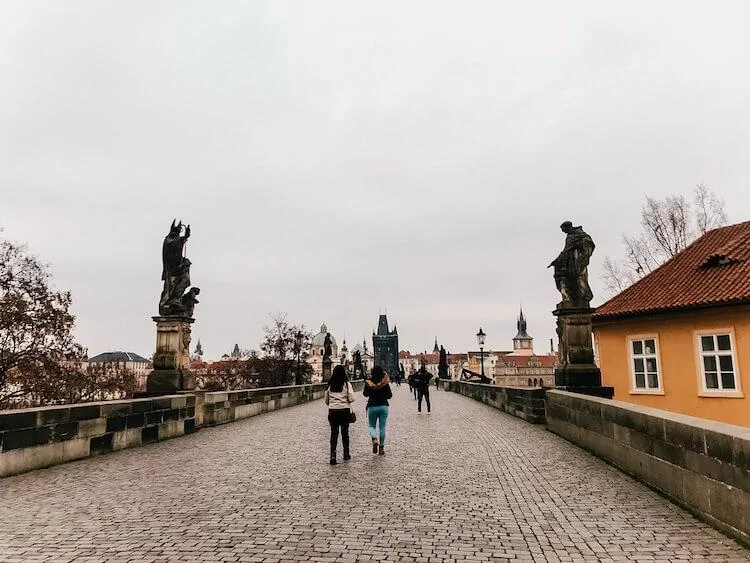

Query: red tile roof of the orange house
[594,221,750,320]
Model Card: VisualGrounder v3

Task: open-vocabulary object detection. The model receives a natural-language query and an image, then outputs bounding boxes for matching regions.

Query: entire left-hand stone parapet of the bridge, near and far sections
[0,380,363,477]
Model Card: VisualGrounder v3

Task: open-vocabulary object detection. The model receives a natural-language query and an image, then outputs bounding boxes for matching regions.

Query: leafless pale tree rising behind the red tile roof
[601,184,728,294]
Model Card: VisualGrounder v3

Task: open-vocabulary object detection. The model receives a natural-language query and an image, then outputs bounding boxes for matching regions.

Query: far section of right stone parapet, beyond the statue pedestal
[440,380,546,424]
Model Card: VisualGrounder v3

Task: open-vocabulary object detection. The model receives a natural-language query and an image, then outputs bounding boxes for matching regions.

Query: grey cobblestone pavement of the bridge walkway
[0,386,750,563]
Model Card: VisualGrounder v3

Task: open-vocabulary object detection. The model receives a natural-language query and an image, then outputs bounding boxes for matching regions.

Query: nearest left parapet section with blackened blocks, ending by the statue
[0,395,195,477]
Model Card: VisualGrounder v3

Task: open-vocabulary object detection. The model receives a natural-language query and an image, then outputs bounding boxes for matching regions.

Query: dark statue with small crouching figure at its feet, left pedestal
[159,221,200,317]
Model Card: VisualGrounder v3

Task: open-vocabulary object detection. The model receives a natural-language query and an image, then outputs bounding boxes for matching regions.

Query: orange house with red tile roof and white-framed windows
[593,222,750,426]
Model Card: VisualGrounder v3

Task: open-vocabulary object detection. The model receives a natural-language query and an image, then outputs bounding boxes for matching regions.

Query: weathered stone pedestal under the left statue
[146,317,195,395]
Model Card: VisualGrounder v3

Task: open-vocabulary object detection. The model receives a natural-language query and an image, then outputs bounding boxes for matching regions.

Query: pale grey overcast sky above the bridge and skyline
[0,0,750,357]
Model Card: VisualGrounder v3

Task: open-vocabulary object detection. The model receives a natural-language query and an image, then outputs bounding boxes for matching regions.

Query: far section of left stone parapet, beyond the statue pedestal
[195,380,364,426]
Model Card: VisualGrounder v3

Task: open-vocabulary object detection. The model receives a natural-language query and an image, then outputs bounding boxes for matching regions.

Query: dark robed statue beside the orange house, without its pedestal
[548,221,595,307]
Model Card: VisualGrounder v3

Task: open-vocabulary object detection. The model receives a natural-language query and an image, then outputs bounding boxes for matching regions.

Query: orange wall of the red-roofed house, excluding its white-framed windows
[594,307,750,426]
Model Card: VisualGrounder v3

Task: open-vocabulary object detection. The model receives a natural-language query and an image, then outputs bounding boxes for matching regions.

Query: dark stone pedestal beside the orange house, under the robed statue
[552,303,614,399]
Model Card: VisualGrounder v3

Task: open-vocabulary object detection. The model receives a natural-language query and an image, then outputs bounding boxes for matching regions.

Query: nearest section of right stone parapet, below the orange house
[547,390,750,544]
